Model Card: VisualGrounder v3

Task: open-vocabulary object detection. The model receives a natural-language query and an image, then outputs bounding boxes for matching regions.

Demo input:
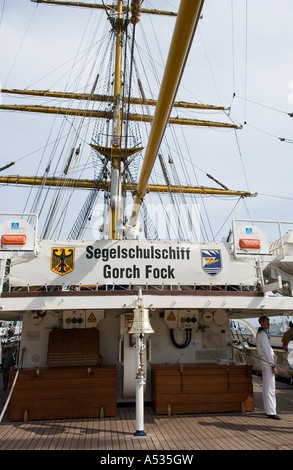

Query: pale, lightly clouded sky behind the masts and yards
[0,0,293,241]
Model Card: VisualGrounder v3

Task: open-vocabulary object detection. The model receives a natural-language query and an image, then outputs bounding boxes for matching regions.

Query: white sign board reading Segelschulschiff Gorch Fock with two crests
[10,240,257,286]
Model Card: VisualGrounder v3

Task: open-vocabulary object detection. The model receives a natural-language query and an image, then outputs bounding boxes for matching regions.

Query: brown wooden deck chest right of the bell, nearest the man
[152,364,254,414]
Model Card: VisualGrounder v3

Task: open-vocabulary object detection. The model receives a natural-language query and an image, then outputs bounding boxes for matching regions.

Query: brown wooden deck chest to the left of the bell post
[8,366,117,421]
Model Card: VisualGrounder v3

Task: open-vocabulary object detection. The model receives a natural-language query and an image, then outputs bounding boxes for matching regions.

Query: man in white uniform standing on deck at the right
[256,315,280,419]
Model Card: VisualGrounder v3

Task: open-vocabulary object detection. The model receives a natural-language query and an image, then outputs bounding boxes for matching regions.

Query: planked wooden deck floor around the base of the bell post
[0,376,293,455]
